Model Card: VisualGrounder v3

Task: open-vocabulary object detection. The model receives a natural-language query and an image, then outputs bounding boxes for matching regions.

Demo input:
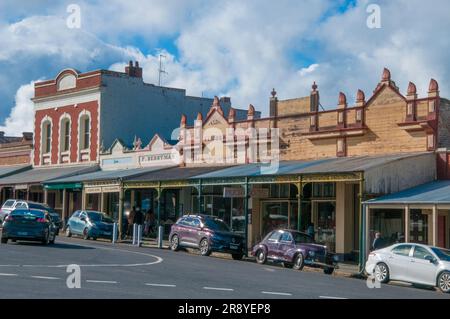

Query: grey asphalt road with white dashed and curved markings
[0,237,450,299]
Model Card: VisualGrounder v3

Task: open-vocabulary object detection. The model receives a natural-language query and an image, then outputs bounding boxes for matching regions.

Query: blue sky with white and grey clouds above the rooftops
[0,0,450,135]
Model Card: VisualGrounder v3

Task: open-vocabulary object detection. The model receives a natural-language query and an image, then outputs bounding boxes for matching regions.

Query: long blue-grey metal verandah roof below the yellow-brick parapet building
[196,153,428,178]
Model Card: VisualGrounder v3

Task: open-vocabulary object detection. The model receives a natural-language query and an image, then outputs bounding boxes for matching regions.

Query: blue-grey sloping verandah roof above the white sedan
[364,180,450,205]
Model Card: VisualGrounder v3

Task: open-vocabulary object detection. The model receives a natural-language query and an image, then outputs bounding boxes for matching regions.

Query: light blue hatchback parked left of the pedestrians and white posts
[66,210,114,240]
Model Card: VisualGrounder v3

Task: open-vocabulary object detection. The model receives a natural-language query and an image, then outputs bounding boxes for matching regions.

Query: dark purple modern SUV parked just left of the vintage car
[169,215,245,260]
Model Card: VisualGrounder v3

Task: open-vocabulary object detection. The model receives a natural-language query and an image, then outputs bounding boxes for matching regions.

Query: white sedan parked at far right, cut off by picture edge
[366,243,450,293]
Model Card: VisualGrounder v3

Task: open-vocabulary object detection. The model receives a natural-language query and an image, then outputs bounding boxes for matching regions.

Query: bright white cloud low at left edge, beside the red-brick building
[0,81,34,136]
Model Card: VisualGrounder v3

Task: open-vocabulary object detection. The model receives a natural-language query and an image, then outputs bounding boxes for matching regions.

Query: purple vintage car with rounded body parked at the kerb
[252,230,337,274]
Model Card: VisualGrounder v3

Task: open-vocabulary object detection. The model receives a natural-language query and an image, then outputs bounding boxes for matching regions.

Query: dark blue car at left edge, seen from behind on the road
[1,209,57,245]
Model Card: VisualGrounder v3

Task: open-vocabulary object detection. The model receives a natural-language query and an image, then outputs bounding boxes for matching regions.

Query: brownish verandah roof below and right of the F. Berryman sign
[124,166,232,182]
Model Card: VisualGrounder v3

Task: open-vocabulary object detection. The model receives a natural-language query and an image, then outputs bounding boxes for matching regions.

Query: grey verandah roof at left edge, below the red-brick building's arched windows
[0,165,98,185]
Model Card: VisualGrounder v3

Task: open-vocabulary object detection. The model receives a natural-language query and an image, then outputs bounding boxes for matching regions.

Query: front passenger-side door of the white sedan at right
[407,245,438,286]
